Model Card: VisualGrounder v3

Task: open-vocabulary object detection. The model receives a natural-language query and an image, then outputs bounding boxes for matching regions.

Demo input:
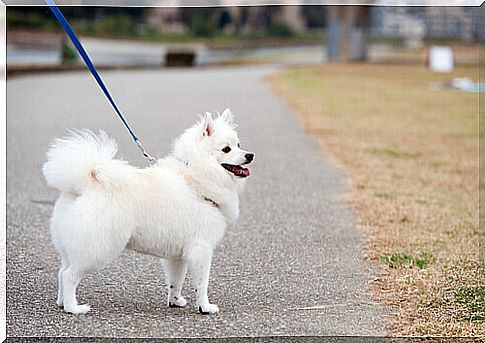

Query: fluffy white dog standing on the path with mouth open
[43,109,254,314]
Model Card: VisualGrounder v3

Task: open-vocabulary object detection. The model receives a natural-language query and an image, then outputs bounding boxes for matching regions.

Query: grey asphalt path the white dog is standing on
[7,67,386,337]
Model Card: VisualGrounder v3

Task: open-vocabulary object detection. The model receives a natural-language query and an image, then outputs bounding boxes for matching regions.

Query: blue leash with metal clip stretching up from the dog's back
[45,0,156,162]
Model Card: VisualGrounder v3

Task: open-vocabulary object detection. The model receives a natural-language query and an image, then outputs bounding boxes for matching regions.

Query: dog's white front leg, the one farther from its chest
[162,259,187,307]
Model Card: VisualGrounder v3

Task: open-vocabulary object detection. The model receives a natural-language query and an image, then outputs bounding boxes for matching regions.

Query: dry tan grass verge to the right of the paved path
[271,64,485,336]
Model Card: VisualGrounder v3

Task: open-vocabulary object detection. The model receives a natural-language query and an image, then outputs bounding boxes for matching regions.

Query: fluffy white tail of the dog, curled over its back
[42,129,135,194]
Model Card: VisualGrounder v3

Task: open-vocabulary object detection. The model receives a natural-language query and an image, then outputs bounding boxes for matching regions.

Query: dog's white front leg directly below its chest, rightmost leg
[188,246,219,314]
